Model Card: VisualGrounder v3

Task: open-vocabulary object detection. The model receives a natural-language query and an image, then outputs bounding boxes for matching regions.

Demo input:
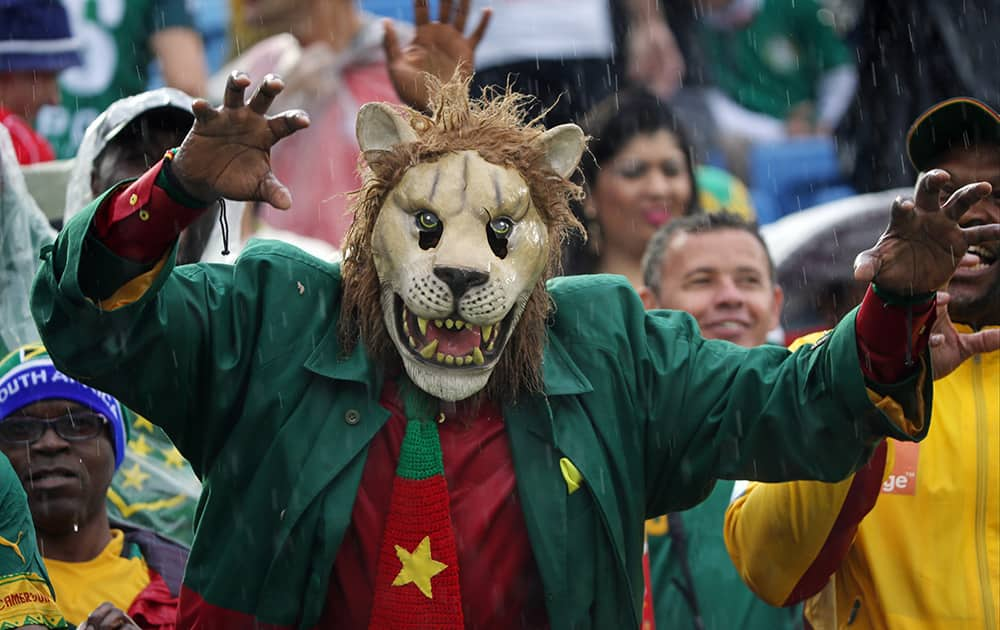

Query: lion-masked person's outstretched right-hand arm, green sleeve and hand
[631,171,1000,515]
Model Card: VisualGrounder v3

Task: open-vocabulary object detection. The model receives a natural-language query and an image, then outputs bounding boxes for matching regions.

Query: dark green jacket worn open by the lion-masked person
[31,199,930,629]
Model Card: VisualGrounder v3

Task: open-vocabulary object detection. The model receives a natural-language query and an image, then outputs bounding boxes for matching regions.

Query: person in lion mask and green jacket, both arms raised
[32,42,1000,628]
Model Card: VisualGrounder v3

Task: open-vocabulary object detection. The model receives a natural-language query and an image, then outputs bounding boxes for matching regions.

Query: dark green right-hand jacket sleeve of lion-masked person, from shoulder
[553,277,931,516]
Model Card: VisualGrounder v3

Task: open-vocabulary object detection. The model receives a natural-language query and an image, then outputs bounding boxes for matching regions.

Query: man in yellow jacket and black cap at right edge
[725,98,1000,630]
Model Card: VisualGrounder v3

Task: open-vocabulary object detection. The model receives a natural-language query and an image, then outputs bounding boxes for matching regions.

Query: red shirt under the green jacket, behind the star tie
[318,382,548,630]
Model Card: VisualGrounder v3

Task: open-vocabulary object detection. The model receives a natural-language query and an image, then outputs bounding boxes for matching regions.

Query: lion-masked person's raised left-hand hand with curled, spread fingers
[171,72,309,210]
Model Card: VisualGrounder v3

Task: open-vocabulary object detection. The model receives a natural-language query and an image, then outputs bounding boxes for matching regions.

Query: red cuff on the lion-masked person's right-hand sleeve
[854,286,937,385]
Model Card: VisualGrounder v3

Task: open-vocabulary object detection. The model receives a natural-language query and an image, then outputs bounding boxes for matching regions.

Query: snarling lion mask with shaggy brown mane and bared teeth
[344,82,585,401]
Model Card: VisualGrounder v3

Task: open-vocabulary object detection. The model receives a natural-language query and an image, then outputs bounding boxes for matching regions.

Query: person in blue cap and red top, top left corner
[0,0,80,164]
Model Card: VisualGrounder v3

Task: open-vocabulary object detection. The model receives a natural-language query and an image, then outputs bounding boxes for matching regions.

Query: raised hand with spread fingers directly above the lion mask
[384,0,491,109]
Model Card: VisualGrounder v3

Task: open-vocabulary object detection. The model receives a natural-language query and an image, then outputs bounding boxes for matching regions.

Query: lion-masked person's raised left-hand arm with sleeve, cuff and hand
[31,75,308,469]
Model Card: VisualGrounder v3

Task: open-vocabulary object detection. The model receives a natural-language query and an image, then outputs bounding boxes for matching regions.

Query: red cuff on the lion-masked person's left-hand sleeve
[94,160,204,263]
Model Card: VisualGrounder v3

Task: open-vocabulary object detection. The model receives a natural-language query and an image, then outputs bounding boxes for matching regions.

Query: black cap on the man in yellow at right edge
[906,96,1000,171]
